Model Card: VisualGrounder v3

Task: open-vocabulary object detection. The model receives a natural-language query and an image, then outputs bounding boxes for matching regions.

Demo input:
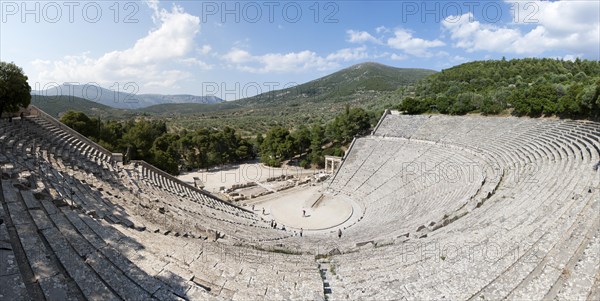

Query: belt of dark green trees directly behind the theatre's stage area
[60,106,376,175]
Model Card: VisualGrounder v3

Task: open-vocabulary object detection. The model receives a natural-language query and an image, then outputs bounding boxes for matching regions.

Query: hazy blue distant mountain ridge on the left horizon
[31,83,223,109]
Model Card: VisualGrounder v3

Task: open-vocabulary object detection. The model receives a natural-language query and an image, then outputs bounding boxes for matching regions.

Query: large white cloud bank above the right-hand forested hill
[442,1,600,59]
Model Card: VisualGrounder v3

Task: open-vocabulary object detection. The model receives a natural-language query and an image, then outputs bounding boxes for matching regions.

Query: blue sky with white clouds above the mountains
[0,0,600,100]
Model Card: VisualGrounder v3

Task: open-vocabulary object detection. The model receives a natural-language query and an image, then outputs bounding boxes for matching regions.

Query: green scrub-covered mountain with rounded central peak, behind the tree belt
[138,63,436,135]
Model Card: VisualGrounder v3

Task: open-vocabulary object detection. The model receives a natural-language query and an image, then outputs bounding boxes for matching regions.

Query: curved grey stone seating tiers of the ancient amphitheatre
[0,113,600,300]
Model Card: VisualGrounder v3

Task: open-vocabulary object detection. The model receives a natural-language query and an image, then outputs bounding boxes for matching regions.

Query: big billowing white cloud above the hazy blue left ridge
[32,1,200,87]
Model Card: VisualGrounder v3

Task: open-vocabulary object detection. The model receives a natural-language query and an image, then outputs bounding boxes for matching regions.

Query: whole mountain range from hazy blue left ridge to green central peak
[34,63,436,135]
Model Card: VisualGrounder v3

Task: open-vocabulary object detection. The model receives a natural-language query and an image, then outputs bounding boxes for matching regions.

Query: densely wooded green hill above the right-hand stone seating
[398,59,600,118]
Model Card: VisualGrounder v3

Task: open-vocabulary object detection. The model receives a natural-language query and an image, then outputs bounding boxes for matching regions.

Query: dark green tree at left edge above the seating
[0,61,31,116]
